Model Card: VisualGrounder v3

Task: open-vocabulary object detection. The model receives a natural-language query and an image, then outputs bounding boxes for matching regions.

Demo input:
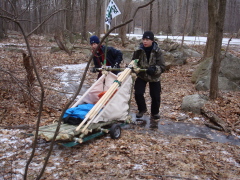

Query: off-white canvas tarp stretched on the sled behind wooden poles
[72,72,133,123]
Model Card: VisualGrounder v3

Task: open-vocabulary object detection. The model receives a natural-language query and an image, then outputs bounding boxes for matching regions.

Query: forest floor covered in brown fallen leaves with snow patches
[0,36,240,180]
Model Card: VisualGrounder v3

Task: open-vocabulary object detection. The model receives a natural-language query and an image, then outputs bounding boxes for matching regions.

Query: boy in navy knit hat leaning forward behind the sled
[90,36,122,78]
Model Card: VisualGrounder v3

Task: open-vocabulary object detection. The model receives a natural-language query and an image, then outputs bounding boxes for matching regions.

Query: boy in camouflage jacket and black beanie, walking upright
[132,31,165,119]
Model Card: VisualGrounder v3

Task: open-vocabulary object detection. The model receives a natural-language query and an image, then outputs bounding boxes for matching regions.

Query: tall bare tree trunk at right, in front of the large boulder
[208,0,226,99]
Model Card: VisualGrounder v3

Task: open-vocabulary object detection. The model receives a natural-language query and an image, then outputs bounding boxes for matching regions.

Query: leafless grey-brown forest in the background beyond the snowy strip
[0,0,240,37]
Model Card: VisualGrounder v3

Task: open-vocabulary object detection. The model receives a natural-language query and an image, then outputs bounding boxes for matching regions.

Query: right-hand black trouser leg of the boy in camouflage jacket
[149,81,161,115]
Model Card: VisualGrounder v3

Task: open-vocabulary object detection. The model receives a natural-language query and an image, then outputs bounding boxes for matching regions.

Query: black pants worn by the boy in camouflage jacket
[134,78,161,114]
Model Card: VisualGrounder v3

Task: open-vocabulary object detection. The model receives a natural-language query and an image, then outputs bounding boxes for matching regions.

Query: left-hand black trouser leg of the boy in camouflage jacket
[134,78,147,112]
